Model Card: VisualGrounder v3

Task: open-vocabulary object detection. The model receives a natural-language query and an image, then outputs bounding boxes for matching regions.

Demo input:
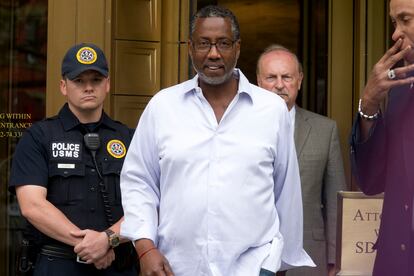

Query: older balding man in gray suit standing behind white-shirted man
[257,45,346,276]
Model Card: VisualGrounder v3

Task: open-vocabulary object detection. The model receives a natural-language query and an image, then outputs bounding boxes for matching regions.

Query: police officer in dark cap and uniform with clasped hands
[9,44,137,276]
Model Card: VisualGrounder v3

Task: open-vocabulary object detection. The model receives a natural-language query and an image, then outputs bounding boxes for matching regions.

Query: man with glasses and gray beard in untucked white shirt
[121,6,313,276]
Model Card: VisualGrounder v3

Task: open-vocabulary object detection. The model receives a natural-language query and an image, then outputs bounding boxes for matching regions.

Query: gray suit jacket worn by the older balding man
[287,106,346,276]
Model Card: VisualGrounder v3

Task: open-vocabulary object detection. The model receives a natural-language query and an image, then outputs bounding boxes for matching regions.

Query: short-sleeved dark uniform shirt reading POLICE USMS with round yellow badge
[9,104,132,243]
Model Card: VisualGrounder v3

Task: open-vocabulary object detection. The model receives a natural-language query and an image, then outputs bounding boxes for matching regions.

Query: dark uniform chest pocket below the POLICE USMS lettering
[47,163,88,205]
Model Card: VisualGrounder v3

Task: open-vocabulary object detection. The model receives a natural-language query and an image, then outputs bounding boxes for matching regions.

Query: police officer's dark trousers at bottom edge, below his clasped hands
[33,255,137,276]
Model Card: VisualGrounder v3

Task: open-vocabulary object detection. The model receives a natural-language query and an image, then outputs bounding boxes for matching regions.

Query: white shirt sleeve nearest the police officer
[120,99,160,243]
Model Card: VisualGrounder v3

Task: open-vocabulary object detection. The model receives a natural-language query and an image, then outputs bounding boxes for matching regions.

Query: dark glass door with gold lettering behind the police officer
[0,0,48,275]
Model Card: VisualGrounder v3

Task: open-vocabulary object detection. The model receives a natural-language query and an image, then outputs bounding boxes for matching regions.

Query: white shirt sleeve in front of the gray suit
[274,110,315,270]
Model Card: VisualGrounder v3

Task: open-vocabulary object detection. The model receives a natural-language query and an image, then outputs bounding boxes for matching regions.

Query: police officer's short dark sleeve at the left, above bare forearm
[9,125,49,193]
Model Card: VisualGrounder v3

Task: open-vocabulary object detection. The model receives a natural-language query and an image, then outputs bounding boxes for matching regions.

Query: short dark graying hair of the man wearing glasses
[190,5,240,40]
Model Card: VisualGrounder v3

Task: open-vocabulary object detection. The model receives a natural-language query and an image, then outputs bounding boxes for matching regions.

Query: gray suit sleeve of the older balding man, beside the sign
[324,123,346,264]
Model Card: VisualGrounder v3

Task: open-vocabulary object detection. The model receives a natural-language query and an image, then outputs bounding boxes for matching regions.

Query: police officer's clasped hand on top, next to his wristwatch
[70,229,109,264]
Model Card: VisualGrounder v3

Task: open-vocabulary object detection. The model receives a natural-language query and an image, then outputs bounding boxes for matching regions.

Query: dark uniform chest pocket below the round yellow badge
[102,160,123,205]
